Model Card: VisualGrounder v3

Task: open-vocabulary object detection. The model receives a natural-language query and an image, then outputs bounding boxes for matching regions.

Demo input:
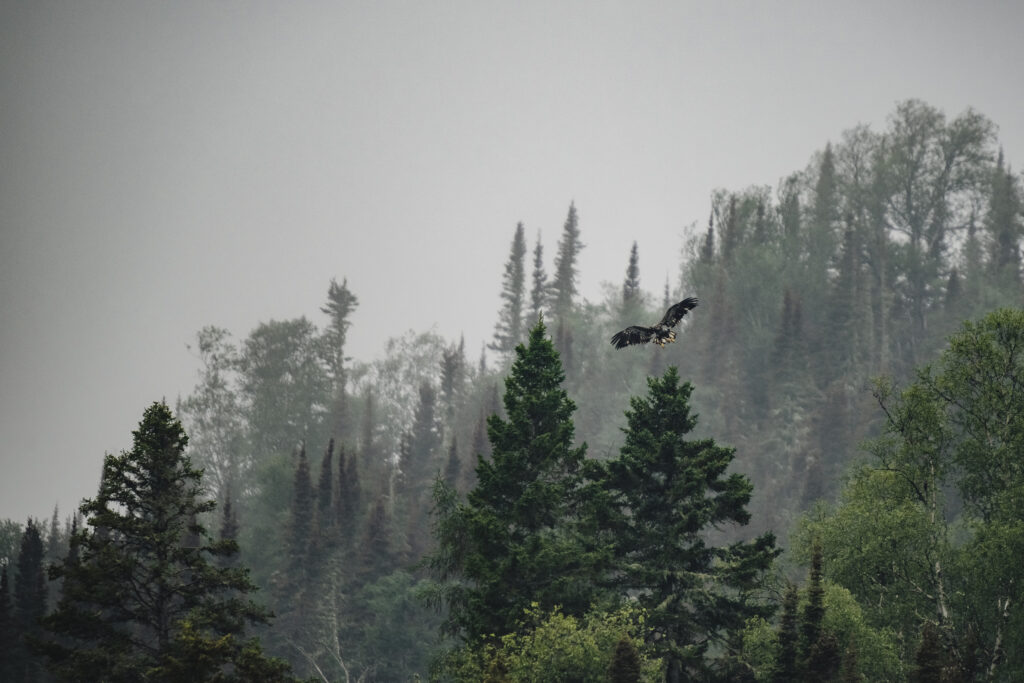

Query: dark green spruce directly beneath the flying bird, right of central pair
[590,367,778,683]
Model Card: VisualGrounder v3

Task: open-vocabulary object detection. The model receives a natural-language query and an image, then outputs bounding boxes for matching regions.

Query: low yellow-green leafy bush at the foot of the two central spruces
[443,603,664,683]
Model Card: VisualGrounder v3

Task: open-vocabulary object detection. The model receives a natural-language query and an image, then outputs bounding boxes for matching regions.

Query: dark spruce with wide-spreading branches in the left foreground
[40,403,292,682]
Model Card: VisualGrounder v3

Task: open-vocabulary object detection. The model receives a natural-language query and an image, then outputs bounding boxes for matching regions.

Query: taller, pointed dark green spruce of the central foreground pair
[429,323,593,640]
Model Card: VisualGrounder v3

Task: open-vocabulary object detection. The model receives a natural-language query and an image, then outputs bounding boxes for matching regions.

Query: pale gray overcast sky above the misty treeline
[0,0,1024,521]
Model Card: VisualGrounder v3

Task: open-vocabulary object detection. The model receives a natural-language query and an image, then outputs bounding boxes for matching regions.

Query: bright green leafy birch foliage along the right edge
[798,309,1024,678]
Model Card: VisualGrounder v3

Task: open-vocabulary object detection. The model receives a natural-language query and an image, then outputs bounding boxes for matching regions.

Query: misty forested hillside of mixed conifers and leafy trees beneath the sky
[0,100,1024,681]
